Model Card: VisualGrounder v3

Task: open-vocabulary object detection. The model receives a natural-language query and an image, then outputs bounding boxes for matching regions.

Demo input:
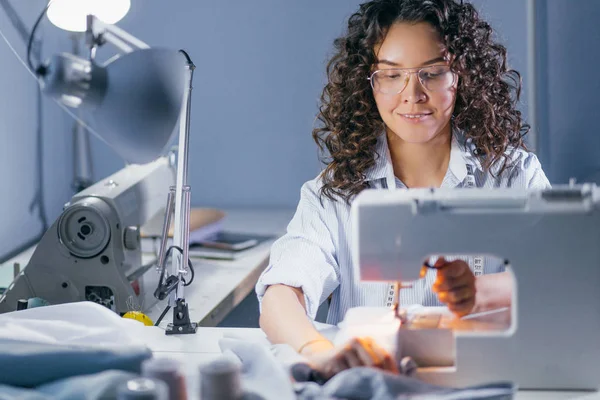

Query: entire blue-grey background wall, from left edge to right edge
[0,0,600,258]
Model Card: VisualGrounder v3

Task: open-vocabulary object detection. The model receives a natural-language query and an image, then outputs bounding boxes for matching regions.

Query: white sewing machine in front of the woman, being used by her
[352,184,600,390]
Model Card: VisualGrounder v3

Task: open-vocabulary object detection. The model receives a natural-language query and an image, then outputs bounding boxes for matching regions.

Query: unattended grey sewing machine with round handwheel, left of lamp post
[0,157,175,314]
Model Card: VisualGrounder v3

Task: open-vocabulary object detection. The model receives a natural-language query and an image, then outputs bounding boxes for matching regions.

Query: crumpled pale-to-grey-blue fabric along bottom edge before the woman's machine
[219,338,516,400]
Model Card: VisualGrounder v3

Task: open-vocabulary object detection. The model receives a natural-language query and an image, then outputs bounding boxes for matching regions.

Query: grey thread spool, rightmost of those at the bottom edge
[200,358,243,400]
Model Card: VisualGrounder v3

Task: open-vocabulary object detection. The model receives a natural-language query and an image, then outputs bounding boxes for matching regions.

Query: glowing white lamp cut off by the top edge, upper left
[48,0,131,32]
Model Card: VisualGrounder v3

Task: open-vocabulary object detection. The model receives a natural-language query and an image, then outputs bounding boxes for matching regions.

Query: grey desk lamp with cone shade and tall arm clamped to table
[28,0,197,334]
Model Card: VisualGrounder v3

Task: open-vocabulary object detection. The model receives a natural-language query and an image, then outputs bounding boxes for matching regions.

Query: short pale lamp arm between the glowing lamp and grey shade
[85,15,150,53]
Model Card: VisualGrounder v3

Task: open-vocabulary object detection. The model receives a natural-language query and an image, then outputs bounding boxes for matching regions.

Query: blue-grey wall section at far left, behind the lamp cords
[0,0,71,260]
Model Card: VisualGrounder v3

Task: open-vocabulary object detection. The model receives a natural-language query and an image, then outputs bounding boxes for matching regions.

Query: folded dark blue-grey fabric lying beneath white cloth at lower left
[0,340,152,388]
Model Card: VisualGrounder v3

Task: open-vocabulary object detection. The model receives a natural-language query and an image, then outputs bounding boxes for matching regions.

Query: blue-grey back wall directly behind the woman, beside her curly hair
[93,0,540,207]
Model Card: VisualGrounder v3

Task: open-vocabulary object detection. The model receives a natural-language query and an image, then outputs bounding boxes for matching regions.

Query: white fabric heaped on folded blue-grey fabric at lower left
[0,302,152,388]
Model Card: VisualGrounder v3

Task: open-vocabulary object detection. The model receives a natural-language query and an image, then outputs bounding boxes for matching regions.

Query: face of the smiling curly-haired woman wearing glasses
[372,22,458,143]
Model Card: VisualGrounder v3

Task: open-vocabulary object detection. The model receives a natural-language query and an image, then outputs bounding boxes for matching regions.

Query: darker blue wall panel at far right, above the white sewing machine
[540,0,600,184]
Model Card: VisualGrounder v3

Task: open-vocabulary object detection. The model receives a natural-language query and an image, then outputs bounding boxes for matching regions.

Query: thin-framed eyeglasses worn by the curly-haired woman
[367,65,456,94]
